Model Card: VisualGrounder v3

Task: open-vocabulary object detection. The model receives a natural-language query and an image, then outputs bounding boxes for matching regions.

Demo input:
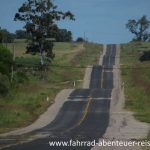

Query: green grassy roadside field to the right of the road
[121,42,150,123]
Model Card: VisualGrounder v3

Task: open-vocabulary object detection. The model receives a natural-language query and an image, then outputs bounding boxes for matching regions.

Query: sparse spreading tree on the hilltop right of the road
[126,16,150,41]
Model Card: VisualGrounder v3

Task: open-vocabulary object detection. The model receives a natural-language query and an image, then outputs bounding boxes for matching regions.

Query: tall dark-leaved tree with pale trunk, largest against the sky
[15,0,74,66]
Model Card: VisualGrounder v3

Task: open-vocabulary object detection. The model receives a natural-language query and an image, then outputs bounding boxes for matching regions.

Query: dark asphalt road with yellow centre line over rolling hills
[1,45,116,150]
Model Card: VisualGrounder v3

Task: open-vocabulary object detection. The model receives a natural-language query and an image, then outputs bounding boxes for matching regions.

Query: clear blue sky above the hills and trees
[0,0,150,44]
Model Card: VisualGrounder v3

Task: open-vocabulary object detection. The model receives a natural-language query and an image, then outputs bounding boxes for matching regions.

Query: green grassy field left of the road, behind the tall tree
[0,42,102,133]
